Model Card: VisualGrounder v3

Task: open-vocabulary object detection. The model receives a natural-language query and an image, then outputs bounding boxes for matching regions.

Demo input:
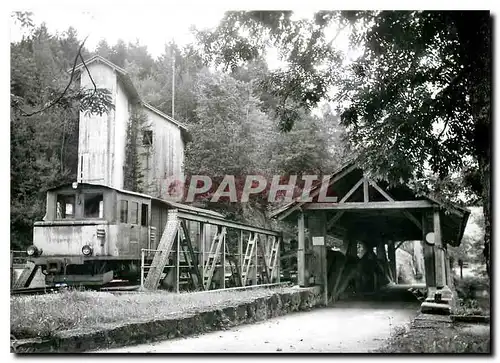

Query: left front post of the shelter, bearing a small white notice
[309,211,328,305]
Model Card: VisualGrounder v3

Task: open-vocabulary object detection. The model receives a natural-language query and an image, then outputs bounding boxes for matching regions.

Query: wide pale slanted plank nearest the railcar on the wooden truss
[144,210,180,290]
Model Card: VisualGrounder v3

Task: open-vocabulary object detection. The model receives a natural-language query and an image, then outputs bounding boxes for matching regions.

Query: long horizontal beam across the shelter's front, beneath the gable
[303,200,433,210]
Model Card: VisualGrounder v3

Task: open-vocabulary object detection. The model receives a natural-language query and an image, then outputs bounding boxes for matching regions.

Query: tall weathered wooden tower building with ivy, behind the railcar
[72,55,188,198]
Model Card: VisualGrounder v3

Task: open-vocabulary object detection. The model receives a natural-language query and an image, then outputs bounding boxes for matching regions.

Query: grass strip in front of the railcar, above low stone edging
[10,288,291,339]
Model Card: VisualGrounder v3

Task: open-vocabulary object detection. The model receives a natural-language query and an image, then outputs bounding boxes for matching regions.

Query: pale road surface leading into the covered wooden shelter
[99,301,419,353]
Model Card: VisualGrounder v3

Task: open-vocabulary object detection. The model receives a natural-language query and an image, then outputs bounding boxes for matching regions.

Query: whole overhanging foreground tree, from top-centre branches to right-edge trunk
[193,11,491,278]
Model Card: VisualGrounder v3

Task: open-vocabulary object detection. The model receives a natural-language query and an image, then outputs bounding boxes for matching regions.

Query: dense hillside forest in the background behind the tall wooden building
[11,19,344,247]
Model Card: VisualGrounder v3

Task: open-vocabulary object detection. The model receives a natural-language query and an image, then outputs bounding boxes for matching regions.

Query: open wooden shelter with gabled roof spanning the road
[271,161,470,310]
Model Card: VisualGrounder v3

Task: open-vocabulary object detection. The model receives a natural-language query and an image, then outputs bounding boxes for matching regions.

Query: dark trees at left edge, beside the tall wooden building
[10,24,110,249]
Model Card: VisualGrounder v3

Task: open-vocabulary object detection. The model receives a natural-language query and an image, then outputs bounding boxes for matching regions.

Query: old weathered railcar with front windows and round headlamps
[27,183,222,286]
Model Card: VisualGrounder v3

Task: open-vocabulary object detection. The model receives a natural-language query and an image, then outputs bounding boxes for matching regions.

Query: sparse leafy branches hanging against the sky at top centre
[196,11,341,131]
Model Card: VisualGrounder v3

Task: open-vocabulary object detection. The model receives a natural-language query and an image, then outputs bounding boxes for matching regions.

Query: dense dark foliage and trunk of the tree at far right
[342,11,491,278]
